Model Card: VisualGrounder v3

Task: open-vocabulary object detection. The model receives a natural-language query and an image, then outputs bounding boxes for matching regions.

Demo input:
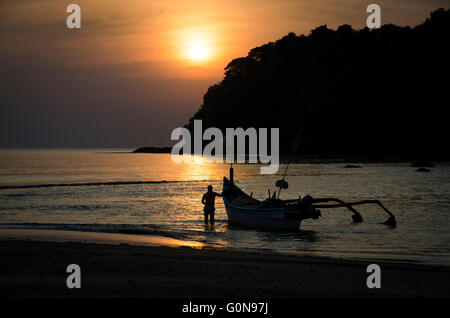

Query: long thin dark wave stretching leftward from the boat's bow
[0,180,219,190]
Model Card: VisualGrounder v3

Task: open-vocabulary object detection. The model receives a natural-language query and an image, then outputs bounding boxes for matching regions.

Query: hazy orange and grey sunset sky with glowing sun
[0,0,450,147]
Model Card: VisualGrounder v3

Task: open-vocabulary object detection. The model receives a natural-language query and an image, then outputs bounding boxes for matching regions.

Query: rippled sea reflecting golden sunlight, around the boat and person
[0,150,450,265]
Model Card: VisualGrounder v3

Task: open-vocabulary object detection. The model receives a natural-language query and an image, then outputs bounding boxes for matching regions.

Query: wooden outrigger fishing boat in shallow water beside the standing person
[223,166,397,230]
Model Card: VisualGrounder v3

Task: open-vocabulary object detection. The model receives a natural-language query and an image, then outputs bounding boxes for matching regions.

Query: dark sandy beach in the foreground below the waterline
[0,230,450,298]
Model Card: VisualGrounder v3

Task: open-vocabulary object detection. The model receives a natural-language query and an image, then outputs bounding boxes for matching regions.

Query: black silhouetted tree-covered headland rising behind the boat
[186,9,450,161]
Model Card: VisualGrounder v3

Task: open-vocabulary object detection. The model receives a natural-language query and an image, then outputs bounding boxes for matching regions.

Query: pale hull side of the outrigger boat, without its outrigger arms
[225,202,301,230]
